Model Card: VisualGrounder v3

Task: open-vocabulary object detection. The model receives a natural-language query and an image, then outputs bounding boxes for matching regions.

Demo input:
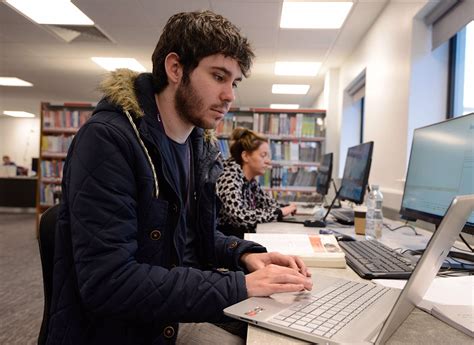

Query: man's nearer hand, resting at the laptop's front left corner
[245,264,313,297]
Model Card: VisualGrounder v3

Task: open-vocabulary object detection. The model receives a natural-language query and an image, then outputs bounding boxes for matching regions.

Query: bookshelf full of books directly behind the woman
[216,108,326,201]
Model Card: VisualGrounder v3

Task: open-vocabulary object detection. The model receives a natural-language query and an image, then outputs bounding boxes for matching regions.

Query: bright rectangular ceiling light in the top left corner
[6,0,94,25]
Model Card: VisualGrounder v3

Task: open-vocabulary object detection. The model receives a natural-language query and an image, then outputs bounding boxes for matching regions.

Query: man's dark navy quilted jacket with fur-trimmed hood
[47,70,265,345]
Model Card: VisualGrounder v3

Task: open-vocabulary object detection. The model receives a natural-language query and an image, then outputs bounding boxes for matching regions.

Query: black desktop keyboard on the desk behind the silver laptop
[339,240,416,279]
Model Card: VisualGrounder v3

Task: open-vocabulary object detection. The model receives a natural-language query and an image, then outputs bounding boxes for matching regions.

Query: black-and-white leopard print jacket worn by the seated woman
[216,158,281,229]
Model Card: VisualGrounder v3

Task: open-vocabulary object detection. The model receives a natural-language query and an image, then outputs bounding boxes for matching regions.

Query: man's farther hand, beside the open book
[240,252,311,277]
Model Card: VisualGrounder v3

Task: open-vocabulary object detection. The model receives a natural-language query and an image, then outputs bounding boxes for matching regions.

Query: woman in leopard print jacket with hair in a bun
[216,128,296,238]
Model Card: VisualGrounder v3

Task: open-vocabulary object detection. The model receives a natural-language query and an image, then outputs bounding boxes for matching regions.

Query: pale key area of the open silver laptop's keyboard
[269,281,390,338]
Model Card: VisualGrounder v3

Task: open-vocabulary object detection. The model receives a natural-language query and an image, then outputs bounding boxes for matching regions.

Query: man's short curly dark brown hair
[152,11,255,92]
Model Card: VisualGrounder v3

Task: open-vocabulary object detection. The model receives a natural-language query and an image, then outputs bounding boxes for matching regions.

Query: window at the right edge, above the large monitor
[448,21,474,117]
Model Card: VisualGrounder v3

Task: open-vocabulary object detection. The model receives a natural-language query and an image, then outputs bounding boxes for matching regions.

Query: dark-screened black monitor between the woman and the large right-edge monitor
[339,141,374,204]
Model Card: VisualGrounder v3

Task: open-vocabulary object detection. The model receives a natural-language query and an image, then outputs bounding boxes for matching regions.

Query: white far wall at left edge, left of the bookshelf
[0,116,40,173]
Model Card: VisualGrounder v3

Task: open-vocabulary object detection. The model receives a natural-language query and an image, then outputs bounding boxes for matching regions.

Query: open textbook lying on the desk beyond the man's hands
[244,233,346,268]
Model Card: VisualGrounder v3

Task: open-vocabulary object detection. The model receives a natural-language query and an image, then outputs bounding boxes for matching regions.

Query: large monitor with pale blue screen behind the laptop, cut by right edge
[400,113,474,234]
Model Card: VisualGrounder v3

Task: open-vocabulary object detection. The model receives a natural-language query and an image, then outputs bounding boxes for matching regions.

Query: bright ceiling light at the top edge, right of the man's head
[280,1,352,29]
